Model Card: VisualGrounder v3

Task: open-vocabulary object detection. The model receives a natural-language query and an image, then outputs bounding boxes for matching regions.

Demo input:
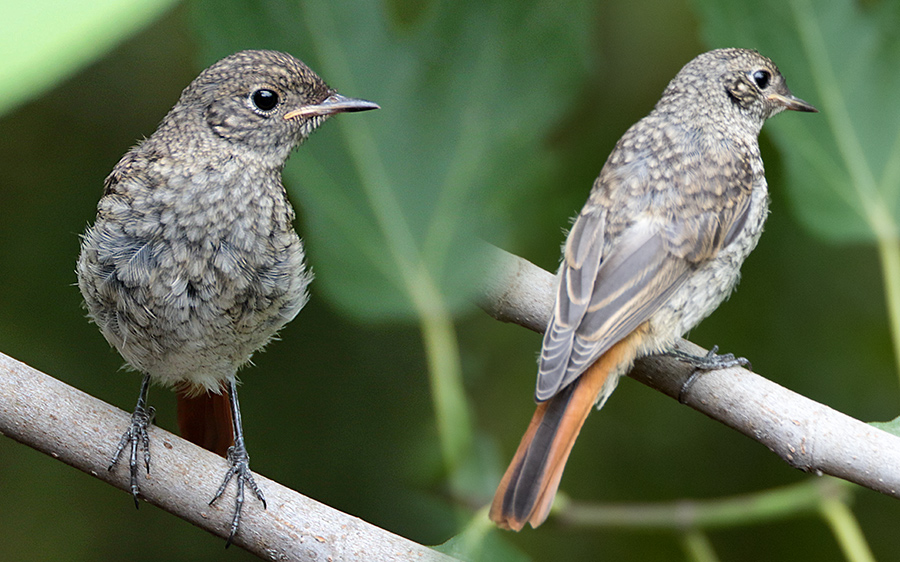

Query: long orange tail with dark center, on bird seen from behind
[490,330,642,531]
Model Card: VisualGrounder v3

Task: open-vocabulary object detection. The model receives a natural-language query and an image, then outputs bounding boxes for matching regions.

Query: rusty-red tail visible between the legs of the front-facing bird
[178,389,234,457]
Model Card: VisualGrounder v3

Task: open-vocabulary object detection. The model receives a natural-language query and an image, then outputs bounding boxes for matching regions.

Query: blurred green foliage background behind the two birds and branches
[0,0,900,561]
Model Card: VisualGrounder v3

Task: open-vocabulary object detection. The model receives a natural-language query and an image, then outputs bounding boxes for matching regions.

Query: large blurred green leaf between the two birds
[196,0,590,318]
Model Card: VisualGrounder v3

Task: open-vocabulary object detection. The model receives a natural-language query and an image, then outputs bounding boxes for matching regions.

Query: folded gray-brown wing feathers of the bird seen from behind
[535,173,750,401]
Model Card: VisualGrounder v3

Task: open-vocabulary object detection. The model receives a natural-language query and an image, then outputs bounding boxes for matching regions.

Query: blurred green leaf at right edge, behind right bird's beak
[697,0,900,245]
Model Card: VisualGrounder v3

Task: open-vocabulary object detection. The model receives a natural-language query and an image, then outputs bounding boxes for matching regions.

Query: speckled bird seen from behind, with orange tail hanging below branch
[490,49,816,530]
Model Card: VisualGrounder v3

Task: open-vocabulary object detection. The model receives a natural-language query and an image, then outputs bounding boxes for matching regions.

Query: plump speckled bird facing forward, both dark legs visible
[78,51,378,544]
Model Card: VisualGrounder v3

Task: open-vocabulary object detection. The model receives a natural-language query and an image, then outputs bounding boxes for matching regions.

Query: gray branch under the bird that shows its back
[478,241,900,498]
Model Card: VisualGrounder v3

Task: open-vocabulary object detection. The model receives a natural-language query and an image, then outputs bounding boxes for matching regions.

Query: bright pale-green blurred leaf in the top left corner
[0,0,181,114]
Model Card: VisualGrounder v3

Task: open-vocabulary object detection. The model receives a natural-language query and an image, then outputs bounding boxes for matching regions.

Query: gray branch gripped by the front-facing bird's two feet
[0,354,454,562]
